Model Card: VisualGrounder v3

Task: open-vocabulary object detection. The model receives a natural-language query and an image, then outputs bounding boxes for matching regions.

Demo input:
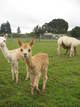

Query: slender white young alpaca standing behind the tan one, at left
[0,37,21,83]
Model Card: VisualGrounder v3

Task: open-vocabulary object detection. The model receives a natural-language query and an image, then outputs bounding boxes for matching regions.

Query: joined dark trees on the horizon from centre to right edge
[33,19,80,37]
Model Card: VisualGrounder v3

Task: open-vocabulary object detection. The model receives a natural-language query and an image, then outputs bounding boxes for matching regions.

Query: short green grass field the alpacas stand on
[0,39,80,107]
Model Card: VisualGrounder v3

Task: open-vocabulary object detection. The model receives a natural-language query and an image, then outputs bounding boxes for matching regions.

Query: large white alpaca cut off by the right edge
[57,36,80,56]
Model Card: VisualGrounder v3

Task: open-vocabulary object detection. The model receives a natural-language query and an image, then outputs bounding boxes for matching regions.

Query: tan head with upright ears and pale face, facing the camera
[18,39,34,59]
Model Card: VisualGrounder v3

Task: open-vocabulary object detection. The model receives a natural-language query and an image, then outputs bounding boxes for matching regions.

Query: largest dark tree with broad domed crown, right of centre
[42,19,68,34]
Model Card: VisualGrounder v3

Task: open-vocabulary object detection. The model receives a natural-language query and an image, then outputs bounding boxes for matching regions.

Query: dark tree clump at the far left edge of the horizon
[1,21,11,34]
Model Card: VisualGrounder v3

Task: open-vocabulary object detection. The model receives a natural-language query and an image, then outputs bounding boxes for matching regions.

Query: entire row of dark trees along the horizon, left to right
[0,19,80,37]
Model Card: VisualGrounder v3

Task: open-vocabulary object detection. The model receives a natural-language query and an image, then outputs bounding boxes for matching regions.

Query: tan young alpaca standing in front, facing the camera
[18,40,48,95]
